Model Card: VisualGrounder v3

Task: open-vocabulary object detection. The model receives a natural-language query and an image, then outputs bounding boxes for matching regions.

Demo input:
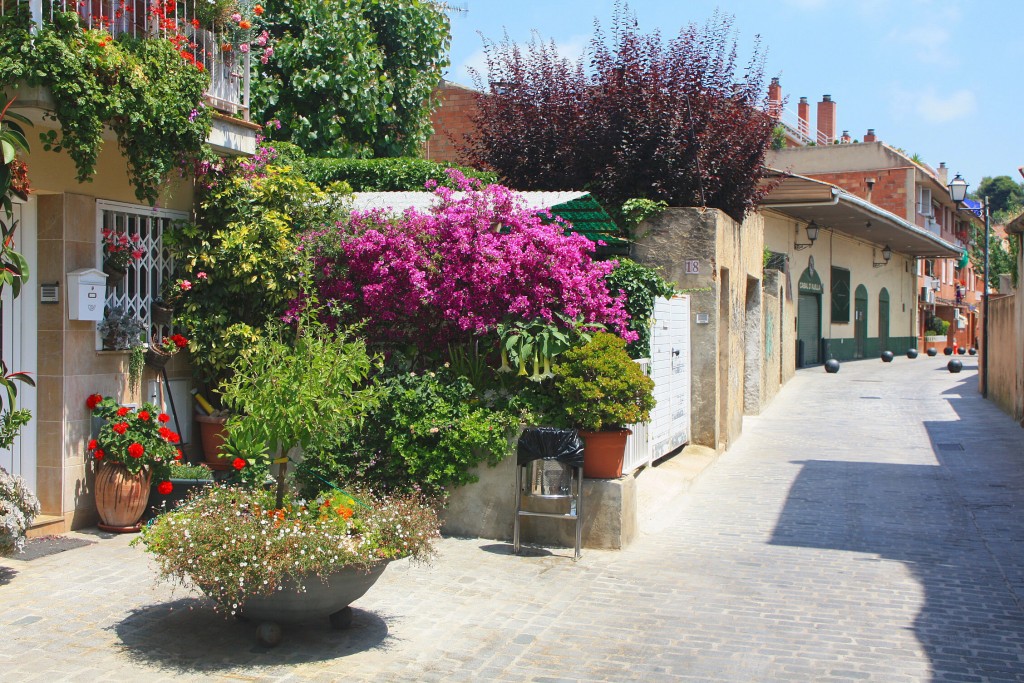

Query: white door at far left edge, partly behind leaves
[0,198,39,493]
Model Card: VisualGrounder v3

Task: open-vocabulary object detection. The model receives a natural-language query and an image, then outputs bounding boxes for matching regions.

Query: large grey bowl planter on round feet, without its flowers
[241,562,387,647]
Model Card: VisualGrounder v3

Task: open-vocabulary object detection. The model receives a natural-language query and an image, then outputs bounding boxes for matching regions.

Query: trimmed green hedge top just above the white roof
[300,157,497,193]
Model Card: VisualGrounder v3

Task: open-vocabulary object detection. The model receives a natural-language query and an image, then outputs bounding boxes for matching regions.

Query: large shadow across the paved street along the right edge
[771,376,1024,681]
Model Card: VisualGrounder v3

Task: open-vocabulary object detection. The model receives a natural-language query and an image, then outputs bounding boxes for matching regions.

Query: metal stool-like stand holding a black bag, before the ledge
[512,427,583,559]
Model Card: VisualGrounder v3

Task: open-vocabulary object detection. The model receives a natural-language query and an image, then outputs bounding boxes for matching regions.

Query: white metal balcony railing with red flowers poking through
[15,0,252,121]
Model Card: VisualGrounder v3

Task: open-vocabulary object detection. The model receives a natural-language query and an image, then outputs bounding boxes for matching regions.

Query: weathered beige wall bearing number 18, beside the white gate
[631,208,764,451]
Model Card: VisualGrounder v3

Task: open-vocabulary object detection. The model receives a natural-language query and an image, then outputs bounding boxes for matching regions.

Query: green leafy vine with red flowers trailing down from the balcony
[0,3,211,204]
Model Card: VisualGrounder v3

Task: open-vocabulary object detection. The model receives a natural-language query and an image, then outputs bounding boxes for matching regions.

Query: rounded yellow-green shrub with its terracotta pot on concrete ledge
[553,332,654,479]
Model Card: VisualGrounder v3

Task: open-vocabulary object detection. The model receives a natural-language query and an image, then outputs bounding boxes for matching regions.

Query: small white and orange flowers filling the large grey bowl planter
[138,486,438,613]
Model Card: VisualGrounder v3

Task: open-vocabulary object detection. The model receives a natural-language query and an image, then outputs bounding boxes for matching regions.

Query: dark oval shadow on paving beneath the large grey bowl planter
[113,598,388,673]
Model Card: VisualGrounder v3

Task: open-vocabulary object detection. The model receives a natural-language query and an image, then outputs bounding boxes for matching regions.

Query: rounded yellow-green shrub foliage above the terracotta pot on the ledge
[554,332,654,431]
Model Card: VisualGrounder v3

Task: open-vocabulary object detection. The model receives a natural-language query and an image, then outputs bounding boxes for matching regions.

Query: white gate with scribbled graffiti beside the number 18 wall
[650,296,692,460]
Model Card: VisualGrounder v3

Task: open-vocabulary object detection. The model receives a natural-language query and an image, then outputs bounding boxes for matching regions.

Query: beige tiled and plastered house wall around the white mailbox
[26,116,193,531]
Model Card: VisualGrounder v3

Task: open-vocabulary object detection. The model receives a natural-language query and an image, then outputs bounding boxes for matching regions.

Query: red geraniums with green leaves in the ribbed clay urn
[85,394,181,485]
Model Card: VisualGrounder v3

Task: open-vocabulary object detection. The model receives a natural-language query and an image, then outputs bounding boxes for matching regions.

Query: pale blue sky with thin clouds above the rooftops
[446,0,1024,189]
